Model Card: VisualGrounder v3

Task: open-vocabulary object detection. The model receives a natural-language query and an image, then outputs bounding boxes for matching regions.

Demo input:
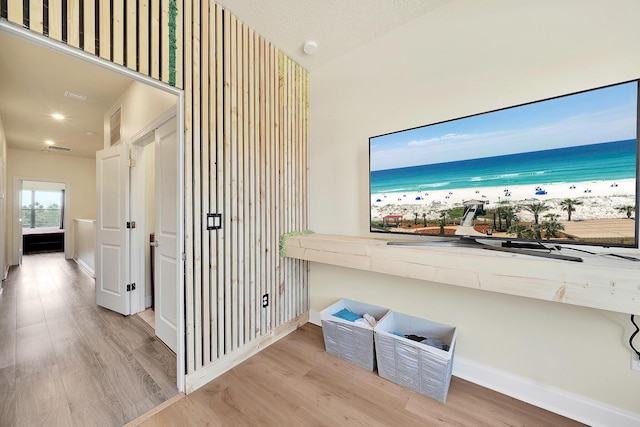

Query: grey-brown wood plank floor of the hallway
[0,252,178,427]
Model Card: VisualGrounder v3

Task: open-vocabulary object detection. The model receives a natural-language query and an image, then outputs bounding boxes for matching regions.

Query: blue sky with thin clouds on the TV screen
[370,82,637,170]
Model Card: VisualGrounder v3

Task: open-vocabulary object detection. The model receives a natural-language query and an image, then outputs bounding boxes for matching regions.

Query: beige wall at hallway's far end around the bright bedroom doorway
[7,148,96,264]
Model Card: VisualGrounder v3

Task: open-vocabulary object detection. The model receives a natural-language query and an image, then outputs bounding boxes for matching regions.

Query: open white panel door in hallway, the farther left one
[95,144,131,315]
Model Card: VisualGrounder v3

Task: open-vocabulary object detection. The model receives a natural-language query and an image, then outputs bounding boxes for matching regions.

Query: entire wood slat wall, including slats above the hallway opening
[6,0,309,380]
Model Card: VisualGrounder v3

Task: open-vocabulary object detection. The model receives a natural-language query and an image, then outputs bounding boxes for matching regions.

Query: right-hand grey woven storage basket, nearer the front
[374,311,457,403]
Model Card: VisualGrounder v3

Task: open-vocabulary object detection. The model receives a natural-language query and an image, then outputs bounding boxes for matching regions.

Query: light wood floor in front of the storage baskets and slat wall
[140,323,582,427]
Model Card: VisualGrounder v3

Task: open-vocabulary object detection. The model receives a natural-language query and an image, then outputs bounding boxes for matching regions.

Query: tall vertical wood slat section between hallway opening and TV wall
[184,1,309,373]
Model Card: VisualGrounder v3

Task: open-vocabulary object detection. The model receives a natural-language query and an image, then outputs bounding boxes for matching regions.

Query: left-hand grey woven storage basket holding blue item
[320,299,389,371]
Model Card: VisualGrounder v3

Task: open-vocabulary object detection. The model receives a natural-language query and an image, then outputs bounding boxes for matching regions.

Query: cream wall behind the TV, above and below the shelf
[310,0,640,420]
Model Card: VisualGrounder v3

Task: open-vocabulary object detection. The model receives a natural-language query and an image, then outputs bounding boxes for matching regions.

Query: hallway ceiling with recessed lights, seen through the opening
[0,31,132,158]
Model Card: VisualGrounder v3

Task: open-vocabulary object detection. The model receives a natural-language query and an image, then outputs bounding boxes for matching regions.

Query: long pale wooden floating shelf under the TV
[285,234,640,314]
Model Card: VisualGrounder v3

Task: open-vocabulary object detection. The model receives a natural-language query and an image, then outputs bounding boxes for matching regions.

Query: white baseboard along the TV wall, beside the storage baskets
[309,310,640,427]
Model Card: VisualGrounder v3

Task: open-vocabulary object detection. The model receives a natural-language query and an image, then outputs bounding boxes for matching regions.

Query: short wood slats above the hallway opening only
[6,0,180,89]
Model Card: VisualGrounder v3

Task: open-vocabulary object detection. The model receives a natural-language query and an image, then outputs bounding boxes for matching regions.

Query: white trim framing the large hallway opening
[0,19,186,392]
